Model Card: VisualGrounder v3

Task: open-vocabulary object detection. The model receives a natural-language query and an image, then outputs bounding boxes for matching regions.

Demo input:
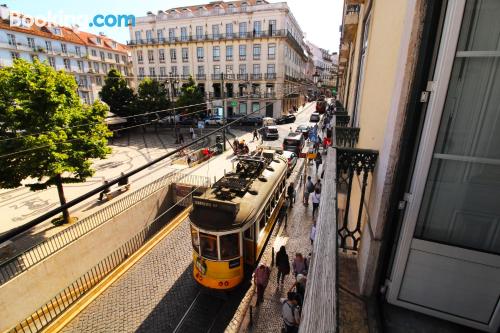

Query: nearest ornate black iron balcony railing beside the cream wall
[336,148,378,251]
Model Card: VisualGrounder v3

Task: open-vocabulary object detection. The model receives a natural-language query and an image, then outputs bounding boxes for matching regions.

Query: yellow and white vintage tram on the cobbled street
[190,150,288,290]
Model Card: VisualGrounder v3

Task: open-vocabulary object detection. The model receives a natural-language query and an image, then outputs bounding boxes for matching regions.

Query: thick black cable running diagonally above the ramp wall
[0,88,304,243]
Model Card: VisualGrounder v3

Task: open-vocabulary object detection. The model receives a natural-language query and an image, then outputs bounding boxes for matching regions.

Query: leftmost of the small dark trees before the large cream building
[99,68,136,117]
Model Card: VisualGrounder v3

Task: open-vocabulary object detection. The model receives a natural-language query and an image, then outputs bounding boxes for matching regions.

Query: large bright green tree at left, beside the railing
[0,60,111,223]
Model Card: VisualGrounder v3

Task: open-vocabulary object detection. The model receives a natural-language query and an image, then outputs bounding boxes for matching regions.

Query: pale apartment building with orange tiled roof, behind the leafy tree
[0,6,135,104]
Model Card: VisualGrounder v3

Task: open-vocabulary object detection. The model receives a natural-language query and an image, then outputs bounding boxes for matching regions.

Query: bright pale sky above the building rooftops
[5,0,343,52]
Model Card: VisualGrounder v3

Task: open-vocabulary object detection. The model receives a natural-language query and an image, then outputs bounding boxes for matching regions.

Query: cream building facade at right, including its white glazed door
[337,0,500,332]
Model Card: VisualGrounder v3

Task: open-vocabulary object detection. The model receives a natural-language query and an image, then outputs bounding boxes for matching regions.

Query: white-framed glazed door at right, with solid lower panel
[387,0,500,332]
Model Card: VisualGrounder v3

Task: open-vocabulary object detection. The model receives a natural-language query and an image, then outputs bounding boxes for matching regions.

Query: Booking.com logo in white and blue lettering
[9,10,135,29]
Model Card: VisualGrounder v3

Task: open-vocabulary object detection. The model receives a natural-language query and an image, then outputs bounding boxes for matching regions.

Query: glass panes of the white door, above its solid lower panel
[415,0,500,254]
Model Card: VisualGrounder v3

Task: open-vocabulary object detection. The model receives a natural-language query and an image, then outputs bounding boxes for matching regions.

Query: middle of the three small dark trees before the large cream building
[137,78,170,116]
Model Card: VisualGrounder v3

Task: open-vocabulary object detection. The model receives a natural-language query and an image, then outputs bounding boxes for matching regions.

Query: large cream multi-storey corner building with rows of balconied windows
[128,0,308,117]
